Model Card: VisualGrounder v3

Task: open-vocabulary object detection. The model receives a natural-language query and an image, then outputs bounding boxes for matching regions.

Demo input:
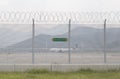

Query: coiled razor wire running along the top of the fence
[0,11,120,24]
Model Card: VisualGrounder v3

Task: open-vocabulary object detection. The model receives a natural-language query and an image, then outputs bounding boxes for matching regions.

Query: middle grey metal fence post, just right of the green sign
[68,19,71,64]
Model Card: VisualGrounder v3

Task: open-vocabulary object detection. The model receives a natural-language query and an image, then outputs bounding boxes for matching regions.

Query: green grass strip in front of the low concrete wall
[0,70,120,79]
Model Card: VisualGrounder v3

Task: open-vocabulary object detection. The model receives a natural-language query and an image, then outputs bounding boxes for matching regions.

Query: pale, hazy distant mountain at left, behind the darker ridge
[0,24,71,48]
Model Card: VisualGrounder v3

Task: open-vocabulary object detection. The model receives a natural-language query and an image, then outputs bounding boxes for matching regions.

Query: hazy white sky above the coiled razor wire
[0,0,120,12]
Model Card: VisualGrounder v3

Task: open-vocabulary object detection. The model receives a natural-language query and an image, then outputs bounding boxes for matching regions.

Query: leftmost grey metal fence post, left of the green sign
[32,19,35,64]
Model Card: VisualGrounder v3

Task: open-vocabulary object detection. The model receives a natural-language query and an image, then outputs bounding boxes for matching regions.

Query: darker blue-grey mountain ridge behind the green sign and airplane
[9,27,120,51]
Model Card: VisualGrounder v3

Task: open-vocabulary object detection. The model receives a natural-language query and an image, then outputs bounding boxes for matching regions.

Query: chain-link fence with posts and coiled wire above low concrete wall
[0,12,120,64]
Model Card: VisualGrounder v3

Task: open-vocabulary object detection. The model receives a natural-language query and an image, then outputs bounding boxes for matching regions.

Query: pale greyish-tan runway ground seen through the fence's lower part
[0,52,120,64]
